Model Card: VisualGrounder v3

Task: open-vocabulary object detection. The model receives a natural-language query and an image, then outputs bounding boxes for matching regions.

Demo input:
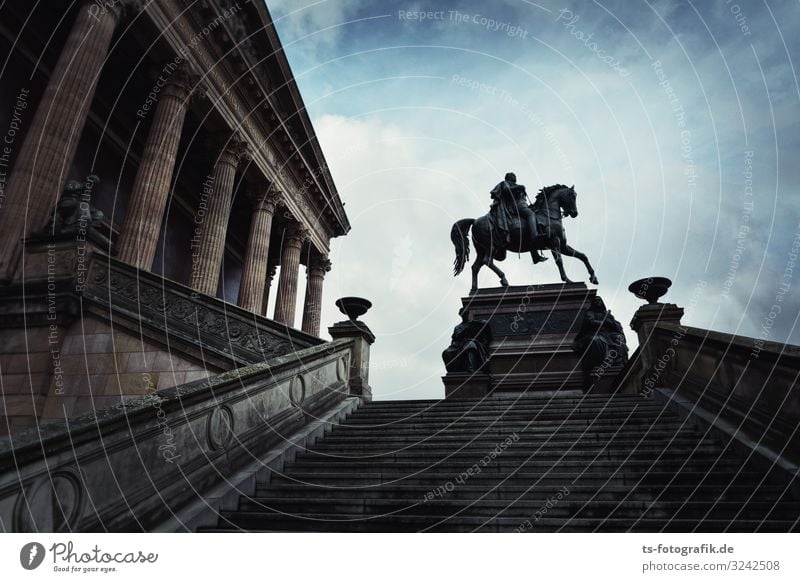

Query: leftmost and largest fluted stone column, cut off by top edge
[0,1,123,280]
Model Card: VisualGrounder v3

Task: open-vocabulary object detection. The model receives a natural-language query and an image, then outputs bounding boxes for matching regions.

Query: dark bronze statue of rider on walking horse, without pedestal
[450,172,597,293]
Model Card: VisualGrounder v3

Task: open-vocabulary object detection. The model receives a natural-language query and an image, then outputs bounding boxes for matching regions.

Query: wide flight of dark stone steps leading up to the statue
[205,394,800,532]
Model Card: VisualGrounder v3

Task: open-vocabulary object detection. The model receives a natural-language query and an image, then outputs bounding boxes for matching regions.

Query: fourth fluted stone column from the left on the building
[234,184,279,313]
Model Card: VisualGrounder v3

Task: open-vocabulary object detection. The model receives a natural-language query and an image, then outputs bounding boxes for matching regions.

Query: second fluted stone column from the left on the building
[118,71,191,270]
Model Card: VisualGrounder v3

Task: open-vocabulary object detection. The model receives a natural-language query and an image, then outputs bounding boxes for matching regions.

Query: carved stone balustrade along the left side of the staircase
[0,339,357,531]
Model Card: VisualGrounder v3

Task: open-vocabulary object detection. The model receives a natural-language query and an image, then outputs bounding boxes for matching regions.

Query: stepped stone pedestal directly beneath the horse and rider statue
[443,283,605,397]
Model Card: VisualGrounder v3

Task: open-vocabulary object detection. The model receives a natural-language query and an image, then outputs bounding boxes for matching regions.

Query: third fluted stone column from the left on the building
[190,141,244,295]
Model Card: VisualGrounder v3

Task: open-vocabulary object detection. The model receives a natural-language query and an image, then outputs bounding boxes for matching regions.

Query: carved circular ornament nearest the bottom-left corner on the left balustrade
[14,470,84,532]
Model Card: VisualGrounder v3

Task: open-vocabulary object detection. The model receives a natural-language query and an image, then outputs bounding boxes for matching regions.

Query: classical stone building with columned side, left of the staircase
[0,0,350,433]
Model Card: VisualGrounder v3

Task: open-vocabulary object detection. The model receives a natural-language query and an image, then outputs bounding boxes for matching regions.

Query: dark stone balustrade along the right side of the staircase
[619,323,800,463]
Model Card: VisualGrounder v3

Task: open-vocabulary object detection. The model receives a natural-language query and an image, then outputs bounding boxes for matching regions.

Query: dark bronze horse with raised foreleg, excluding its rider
[450,184,598,293]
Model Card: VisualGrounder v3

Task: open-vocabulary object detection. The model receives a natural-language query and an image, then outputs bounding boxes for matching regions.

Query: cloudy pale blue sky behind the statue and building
[268,0,800,399]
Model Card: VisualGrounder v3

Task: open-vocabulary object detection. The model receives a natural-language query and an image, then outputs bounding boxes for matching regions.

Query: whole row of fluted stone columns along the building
[0,1,330,335]
